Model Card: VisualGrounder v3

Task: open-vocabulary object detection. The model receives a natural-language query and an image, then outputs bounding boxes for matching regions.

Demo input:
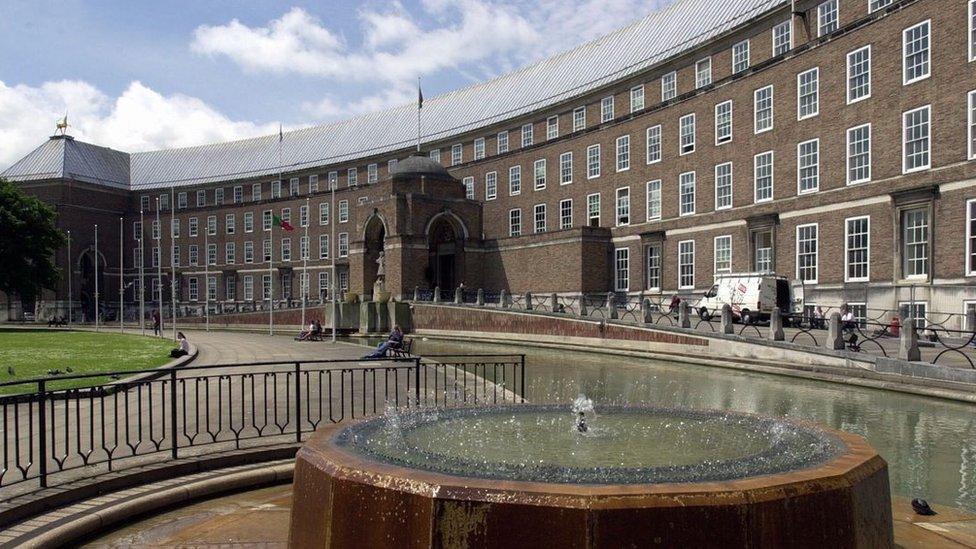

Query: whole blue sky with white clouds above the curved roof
[0,0,670,169]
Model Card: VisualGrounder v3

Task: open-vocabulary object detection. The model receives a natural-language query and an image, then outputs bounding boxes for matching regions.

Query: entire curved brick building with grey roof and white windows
[3,0,976,327]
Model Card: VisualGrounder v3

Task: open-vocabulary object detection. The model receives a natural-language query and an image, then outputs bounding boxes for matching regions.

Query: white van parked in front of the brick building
[695,273,793,324]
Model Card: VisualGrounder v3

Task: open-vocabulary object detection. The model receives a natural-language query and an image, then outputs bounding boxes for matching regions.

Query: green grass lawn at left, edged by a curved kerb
[0,329,174,394]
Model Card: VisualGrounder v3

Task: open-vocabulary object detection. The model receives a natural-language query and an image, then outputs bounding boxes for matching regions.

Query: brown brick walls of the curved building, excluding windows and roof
[5,0,976,326]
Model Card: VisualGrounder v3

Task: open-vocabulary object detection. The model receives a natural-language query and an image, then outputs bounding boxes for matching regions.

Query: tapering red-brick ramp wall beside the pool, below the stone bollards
[412,303,709,347]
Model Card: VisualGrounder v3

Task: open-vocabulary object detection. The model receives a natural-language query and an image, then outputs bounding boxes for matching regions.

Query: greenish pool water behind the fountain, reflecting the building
[414,338,976,511]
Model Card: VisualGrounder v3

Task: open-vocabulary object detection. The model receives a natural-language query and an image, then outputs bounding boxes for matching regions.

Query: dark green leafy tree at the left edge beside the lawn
[0,179,67,300]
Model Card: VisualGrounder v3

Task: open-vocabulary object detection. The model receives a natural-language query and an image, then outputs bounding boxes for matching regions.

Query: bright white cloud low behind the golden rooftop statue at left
[0,80,278,169]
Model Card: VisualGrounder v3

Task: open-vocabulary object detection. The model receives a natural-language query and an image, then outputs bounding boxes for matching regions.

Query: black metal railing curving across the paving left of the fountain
[0,355,525,502]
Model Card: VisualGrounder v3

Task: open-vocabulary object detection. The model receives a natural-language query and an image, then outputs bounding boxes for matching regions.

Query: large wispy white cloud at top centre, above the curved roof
[191,0,672,119]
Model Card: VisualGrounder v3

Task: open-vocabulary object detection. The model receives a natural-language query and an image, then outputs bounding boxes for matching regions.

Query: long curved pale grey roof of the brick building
[2,0,789,189]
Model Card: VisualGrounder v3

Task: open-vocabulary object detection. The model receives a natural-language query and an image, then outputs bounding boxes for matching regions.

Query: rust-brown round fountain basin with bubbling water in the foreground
[290,405,892,547]
